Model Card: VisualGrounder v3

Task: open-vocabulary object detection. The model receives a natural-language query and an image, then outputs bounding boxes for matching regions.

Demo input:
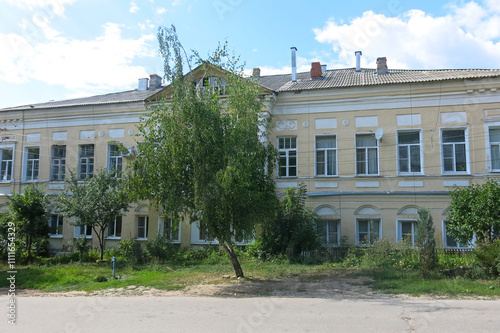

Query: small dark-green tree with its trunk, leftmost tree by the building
[4,185,49,260]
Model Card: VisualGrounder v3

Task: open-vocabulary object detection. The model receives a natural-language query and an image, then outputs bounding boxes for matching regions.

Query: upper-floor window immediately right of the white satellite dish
[398,131,422,173]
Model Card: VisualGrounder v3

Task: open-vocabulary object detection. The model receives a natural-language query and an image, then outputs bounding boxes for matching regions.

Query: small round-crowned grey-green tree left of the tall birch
[56,169,130,260]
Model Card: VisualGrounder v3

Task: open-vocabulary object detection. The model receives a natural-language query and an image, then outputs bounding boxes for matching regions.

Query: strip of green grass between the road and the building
[0,257,500,297]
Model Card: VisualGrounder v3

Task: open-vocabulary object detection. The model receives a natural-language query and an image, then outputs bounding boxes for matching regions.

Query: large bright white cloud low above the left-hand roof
[0,23,156,94]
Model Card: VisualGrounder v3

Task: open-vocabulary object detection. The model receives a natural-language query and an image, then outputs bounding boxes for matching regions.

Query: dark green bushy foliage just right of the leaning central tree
[258,184,319,256]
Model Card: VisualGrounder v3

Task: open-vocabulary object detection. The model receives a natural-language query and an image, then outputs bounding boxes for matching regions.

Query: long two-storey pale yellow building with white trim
[0,48,500,250]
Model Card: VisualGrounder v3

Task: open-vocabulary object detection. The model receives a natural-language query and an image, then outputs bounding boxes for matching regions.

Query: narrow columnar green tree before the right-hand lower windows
[415,207,438,276]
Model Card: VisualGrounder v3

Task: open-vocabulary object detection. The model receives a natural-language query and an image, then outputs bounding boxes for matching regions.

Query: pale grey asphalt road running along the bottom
[0,296,500,333]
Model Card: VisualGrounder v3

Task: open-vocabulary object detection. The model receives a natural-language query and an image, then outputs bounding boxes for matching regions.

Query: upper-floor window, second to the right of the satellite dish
[442,129,467,172]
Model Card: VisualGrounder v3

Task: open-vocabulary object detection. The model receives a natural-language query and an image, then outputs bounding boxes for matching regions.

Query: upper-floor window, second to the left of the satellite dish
[316,135,337,176]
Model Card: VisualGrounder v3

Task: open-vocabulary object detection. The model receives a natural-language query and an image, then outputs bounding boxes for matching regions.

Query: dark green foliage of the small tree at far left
[0,185,49,261]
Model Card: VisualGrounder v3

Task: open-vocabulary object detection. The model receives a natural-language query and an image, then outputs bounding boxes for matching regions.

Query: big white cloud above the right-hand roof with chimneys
[314,1,500,69]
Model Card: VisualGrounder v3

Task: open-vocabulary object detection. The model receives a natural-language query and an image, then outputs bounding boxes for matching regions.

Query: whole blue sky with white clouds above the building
[0,0,500,108]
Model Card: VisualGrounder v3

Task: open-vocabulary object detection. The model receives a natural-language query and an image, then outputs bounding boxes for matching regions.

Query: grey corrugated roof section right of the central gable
[255,68,500,92]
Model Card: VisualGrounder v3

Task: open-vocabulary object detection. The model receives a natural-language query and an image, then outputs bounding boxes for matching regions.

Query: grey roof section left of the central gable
[0,87,163,112]
